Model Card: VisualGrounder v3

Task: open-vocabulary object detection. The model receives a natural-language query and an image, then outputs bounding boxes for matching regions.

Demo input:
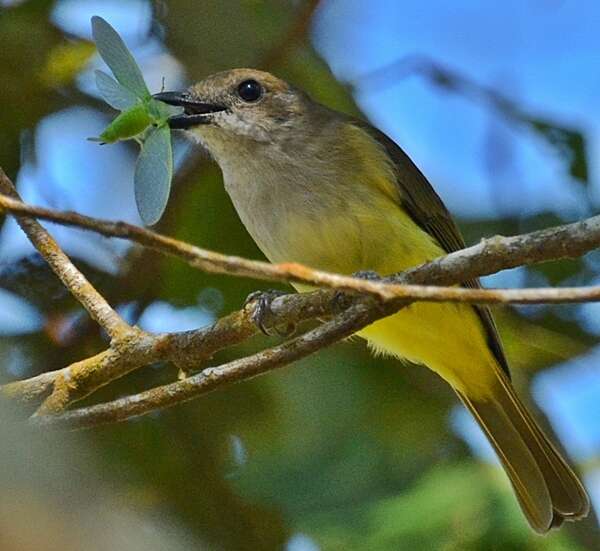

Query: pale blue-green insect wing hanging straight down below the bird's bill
[134,125,173,226]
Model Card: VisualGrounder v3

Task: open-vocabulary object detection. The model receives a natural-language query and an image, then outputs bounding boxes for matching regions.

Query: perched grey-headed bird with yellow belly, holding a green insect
[155,69,589,533]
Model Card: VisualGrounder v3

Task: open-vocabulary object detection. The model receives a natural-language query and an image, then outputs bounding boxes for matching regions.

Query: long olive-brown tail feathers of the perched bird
[457,370,590,534]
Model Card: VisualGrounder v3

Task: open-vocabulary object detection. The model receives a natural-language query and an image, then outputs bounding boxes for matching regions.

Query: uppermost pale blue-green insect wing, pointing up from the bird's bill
[92,15,150,99]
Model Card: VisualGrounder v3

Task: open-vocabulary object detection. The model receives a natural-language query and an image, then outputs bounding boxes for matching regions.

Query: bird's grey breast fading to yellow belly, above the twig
[223,156,440,280]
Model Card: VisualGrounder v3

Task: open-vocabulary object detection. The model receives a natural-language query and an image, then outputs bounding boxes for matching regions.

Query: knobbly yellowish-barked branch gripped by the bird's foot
[0,292,335,414]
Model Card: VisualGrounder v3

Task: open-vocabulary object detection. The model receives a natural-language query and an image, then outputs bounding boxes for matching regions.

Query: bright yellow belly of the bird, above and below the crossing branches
[284,201,496,398]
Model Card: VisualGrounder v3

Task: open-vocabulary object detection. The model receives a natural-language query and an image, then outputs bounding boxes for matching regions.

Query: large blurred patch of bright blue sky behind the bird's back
[314,0,600,218]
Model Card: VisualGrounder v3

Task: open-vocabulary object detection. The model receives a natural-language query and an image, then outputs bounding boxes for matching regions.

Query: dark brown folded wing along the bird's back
[355,121,510,377]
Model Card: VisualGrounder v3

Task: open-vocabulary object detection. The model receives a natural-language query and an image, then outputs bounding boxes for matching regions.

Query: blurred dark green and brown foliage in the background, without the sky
[0,0,597,551]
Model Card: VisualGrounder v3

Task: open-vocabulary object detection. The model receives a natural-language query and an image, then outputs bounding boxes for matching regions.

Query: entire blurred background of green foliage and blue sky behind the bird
[0,0,600,551]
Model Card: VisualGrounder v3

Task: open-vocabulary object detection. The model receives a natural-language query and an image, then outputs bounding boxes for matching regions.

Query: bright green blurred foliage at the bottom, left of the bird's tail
[307,461,581,551]
